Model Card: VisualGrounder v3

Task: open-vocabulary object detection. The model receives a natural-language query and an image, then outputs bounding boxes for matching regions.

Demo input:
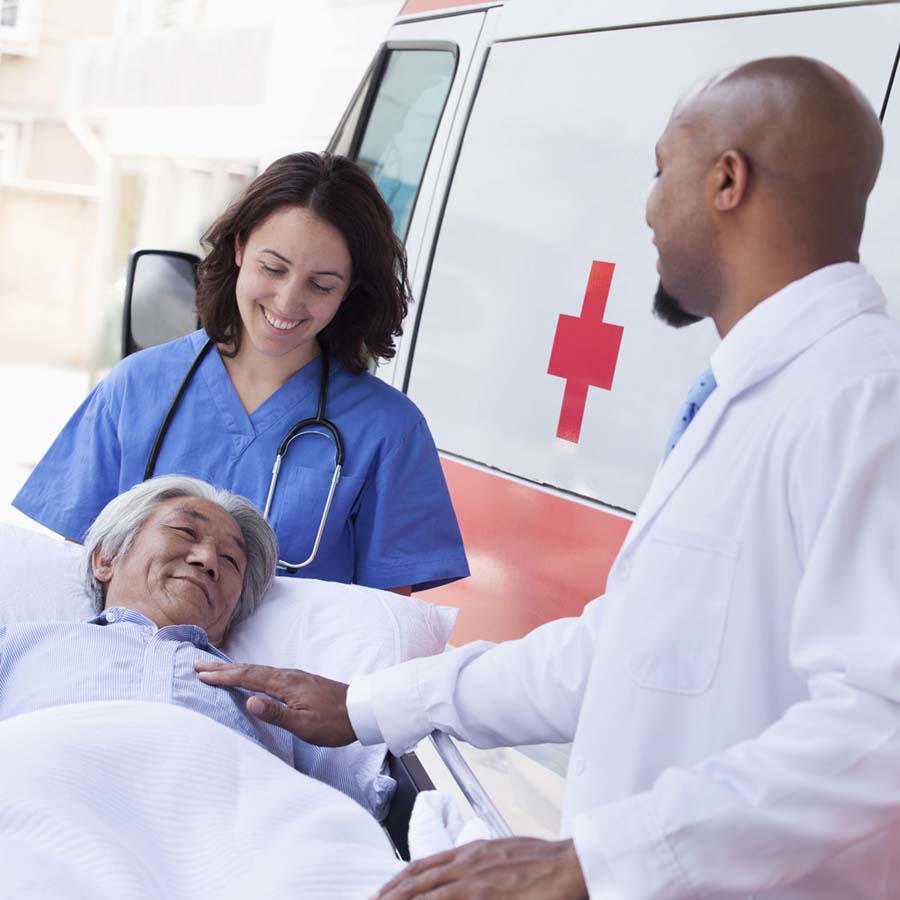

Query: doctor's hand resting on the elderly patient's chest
[194,660,356,747]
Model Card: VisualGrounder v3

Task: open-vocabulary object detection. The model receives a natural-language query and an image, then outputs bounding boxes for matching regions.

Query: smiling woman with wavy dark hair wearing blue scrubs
[14,153,469,593]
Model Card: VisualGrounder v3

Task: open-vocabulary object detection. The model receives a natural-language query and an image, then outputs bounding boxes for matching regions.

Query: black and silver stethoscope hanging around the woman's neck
[144,338,344,575]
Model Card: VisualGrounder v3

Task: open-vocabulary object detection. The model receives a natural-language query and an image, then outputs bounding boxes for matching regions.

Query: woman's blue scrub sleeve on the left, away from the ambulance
[13,380,121,542]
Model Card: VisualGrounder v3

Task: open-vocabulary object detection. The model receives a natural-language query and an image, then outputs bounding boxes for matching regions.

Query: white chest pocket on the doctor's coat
[626,528,740,694]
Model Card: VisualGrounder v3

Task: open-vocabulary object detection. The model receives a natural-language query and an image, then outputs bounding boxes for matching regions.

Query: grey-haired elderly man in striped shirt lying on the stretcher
[0,477,293,764]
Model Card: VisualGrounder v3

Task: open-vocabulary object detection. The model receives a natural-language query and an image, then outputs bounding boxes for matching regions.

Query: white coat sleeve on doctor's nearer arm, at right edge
[572,375,900,900]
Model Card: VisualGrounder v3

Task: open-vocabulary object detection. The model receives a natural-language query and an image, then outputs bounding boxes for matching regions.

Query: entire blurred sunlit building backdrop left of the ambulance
[0,0,399,368]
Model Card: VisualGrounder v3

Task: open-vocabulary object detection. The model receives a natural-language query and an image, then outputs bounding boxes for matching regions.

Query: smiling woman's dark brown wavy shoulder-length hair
[197,153,410,374]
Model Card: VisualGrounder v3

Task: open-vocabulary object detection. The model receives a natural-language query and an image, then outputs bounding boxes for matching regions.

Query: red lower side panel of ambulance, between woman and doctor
[425,458,631,645]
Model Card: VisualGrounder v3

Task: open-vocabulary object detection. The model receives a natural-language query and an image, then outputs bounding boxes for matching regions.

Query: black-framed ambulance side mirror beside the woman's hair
[122,250,200,358]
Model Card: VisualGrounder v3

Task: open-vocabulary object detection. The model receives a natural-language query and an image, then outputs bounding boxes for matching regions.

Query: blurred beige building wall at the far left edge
[0,0,115,364]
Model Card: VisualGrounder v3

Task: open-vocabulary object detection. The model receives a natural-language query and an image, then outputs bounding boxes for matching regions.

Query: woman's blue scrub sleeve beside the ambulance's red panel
[353,414,469,590]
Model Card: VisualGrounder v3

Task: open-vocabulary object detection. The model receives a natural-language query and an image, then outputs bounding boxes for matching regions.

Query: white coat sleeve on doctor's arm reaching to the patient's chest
[348,597,603,754]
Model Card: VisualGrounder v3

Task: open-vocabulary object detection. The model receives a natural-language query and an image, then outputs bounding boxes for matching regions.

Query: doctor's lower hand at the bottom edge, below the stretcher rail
[370,838,588,900]
